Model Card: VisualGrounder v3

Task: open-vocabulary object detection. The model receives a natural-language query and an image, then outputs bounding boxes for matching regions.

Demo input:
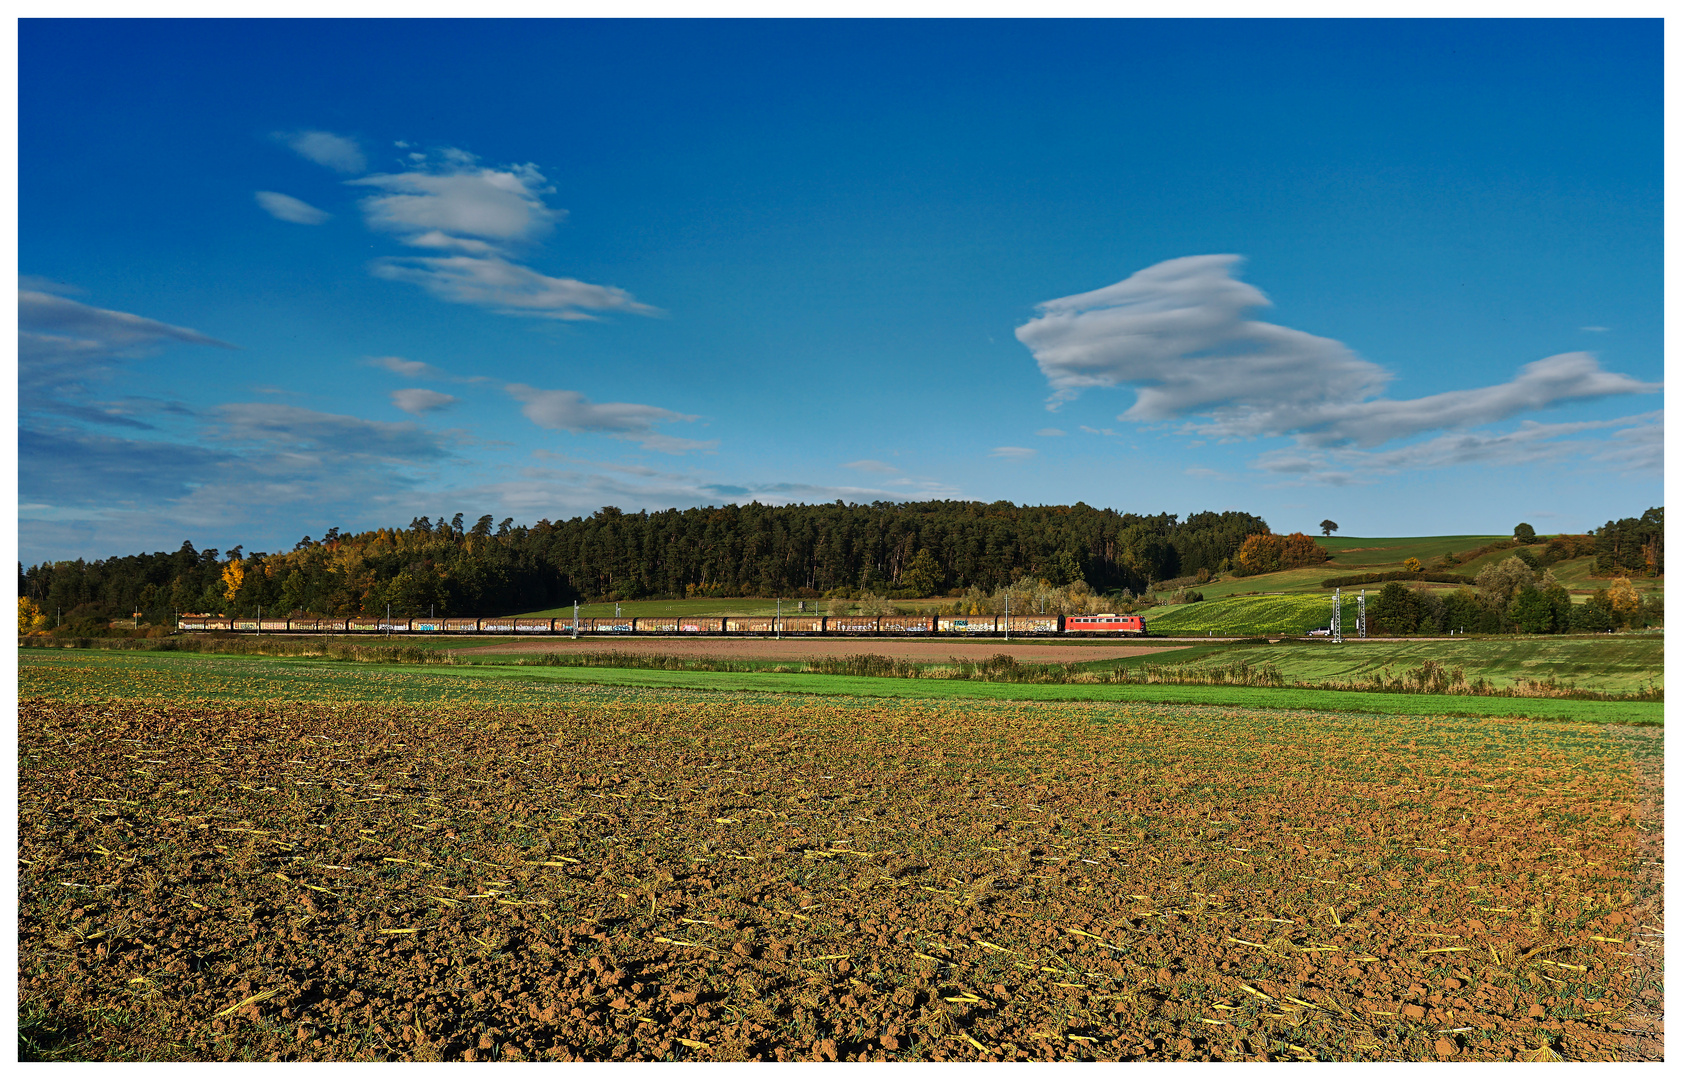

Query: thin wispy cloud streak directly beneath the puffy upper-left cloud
[372,256,658,320]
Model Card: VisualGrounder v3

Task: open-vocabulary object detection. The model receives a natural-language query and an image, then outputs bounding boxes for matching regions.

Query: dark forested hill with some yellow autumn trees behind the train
[19,501,1268,622]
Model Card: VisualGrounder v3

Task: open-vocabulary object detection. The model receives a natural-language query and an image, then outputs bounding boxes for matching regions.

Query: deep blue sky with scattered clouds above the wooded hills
[19,20,1663,564]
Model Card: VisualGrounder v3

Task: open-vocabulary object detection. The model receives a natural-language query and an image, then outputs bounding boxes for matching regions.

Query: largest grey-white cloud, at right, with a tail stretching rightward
[1016,256,1662,446]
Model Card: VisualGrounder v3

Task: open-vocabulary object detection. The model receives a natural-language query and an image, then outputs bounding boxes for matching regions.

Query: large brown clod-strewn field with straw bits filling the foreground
[19,688,1663,1060]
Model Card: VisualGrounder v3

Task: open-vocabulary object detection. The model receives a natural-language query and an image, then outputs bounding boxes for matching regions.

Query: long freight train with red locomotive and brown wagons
[177,614,1145,638]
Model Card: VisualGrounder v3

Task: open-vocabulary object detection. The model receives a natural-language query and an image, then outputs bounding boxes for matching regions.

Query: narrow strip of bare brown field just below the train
[451,636,1186,663]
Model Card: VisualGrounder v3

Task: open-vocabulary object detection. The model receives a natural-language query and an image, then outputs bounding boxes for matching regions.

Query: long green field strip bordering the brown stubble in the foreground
[19,649,1663,723]
